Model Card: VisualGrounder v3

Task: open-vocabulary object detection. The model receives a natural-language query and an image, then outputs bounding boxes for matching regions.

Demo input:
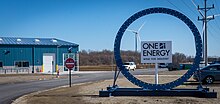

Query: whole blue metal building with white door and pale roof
[0,37,79,74]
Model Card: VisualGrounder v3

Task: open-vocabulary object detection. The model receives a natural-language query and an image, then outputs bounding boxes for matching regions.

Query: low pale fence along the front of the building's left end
[0,68,30,74]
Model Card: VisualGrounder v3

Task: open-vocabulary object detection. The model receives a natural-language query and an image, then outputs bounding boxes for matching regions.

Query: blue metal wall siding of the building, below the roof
[0,45,78,66]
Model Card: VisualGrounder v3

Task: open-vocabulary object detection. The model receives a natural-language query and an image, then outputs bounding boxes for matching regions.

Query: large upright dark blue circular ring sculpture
[114,7,202,90]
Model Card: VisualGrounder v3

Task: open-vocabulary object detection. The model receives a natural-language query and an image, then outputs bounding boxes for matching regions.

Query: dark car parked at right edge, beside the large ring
[193,64,220,84]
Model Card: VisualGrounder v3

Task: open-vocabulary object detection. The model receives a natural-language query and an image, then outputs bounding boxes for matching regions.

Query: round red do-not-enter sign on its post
[65,58,75,87]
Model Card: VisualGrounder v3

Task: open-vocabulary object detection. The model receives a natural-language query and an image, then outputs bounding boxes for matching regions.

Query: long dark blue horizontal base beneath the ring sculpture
[99,87,217,98]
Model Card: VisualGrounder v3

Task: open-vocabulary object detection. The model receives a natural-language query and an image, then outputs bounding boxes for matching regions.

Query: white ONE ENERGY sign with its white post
[141,41,172,84]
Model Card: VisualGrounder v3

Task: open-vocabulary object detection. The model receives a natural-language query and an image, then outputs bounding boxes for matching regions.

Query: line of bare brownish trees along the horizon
[79,50,220,66]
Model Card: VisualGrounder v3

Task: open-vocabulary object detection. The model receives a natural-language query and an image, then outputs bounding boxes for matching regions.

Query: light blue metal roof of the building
[0,37,79,46]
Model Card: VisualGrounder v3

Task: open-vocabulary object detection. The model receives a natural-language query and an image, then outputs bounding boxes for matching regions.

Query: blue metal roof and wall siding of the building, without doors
[0,37,79,73]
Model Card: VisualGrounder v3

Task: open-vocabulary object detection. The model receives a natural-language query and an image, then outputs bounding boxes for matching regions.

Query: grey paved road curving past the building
[0,69,167,104]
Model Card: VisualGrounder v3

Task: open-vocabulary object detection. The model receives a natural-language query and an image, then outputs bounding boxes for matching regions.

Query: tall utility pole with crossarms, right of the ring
[198,0,214,66]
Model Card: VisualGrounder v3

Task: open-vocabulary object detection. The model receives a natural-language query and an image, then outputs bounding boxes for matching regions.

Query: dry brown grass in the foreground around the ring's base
[13,71,220,104]
